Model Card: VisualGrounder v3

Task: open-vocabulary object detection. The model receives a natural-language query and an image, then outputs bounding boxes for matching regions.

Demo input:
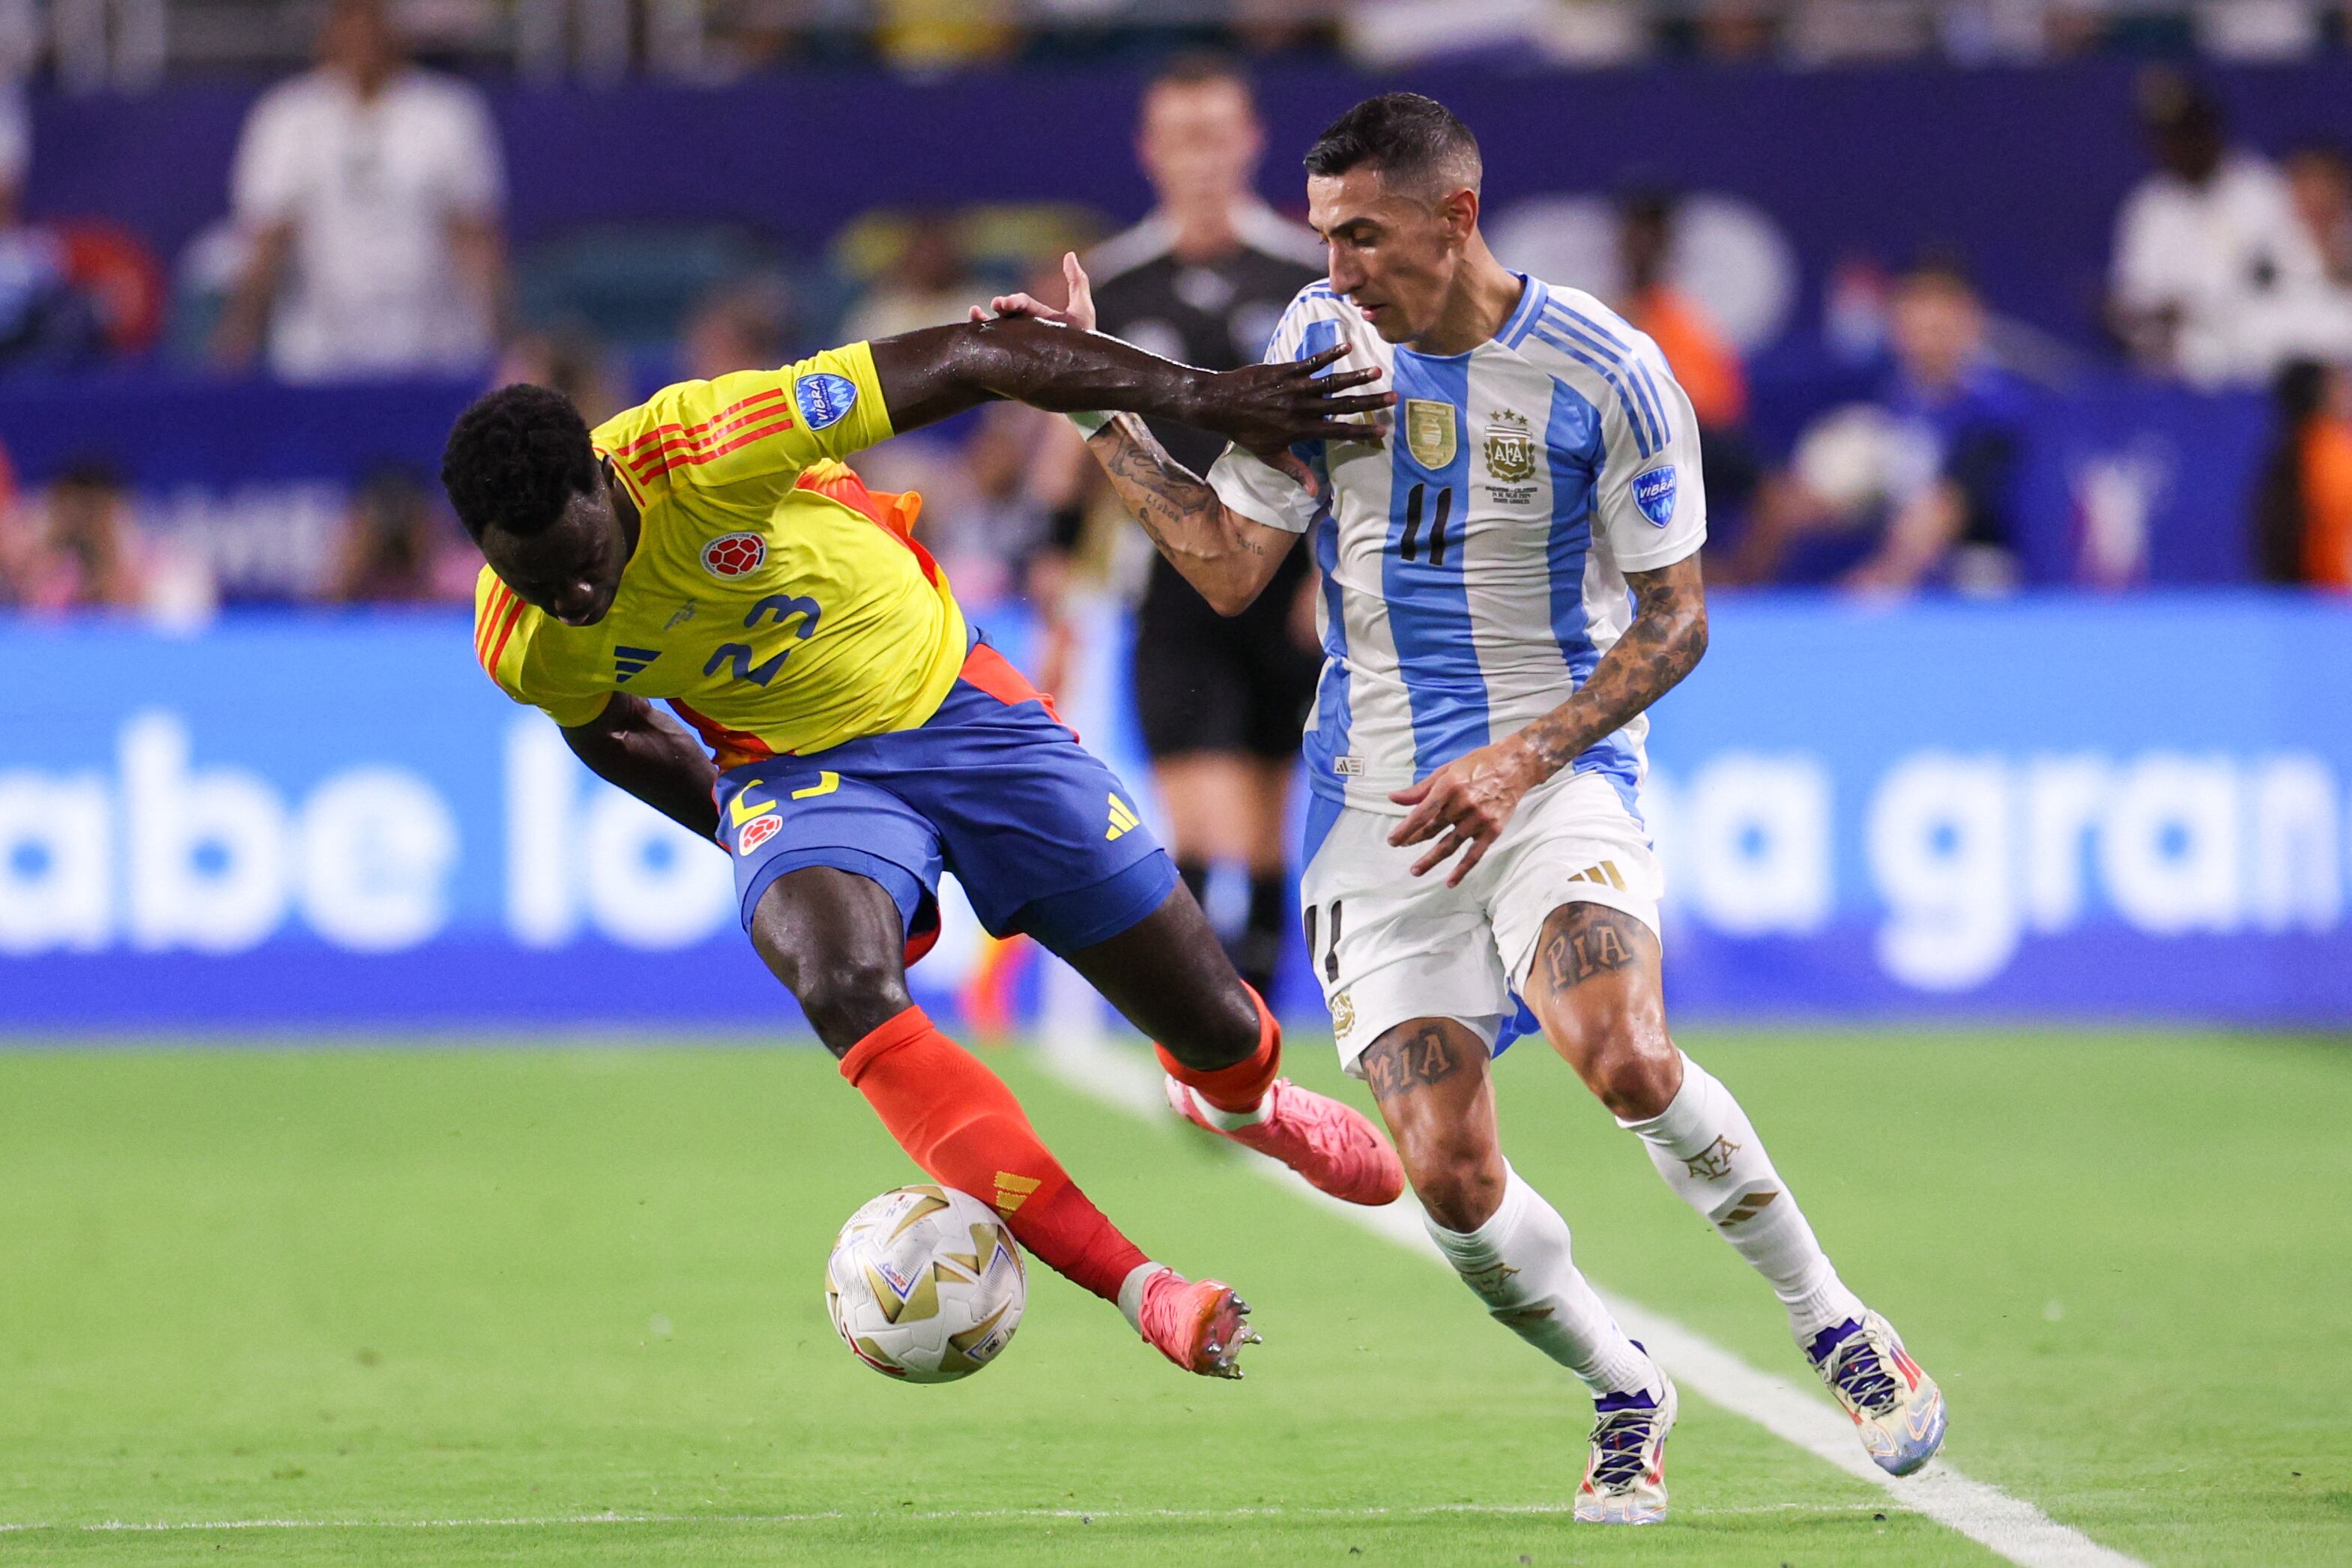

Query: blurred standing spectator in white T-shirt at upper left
[214,0,506,381]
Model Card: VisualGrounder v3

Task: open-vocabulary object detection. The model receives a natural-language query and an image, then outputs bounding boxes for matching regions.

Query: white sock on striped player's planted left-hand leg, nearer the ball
[1423,1163,1663,1394]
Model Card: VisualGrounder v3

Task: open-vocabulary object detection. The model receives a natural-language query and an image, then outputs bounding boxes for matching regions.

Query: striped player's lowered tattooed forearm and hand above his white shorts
[1388,555,1708,886]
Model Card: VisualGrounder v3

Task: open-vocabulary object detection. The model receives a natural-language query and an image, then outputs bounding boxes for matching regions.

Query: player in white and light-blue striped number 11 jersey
[1021,94,1945,1523]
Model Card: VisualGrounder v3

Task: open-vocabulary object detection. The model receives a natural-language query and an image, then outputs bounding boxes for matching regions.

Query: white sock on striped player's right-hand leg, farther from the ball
[1618,1056,1863,1345]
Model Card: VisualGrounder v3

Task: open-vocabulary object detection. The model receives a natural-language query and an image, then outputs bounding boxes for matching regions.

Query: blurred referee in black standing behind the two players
[1056,54,1324,994]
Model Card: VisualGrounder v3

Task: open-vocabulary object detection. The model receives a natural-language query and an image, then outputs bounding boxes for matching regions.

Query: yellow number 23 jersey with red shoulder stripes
[473,343,969,769]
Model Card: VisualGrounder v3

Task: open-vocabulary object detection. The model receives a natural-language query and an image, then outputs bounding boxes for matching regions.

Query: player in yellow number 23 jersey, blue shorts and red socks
[442,320,1404,1378]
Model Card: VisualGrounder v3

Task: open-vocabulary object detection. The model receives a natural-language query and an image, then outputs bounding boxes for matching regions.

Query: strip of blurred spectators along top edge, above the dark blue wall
[22,0,2352,85]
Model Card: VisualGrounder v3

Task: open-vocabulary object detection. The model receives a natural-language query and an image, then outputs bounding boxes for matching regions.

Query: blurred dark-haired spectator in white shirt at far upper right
[2110,73,2319,386]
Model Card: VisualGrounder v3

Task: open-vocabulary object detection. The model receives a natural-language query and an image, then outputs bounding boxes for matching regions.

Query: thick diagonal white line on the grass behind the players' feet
[1039,1029,2145,1568]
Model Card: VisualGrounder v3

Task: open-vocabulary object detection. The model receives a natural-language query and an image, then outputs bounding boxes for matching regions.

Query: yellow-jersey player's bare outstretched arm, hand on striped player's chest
[873,315,1392,454]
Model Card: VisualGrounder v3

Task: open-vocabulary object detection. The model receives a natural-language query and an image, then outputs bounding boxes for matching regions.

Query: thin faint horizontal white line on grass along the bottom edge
[0,1502,1872,1535]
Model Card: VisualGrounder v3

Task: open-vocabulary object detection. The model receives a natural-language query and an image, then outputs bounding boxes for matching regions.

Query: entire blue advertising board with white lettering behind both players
[0,595,2352,1035]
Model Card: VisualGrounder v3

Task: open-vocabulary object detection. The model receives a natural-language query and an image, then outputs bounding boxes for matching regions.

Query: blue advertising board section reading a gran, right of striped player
[1644,593,2352,1025]
